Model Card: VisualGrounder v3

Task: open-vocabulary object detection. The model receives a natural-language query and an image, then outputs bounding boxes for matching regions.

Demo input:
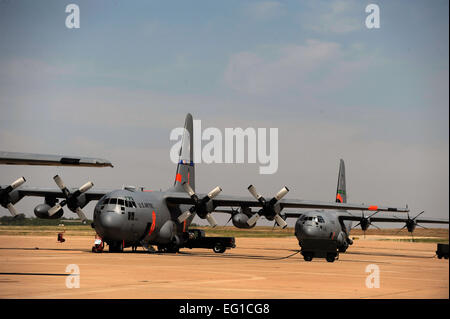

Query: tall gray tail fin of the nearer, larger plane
[174,113,195,191]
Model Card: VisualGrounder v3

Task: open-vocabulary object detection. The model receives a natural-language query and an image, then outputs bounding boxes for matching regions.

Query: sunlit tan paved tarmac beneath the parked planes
[0,235,449,299]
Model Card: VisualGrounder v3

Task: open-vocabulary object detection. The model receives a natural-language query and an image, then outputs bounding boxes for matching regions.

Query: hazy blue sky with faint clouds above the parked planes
[0,0,449,225]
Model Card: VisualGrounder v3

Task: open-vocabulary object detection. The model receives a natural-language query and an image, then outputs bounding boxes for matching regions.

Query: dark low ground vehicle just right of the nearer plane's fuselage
[184,229,236,254]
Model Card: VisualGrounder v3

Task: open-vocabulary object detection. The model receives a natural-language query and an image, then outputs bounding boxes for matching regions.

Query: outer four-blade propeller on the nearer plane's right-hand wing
[247,185,289,228]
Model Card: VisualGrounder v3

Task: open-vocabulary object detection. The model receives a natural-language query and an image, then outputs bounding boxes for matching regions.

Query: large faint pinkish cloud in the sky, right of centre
[224,40,371,95]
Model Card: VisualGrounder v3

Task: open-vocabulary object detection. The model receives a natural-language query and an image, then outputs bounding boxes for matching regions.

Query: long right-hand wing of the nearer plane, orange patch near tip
[165,192,409,212]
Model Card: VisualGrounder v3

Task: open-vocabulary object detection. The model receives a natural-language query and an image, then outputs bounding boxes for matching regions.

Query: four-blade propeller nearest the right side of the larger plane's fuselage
[178,182,222,227]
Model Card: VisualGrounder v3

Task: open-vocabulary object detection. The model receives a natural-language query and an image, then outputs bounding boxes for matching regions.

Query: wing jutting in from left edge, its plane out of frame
[0,151,113,167]
